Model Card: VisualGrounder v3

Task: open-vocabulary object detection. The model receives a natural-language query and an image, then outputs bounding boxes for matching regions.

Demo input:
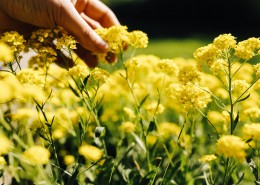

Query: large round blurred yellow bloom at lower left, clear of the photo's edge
[23,146,50,165]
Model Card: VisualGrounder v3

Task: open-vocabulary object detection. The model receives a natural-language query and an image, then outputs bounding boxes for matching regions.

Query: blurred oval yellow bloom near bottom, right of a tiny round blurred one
[79,144,103,161]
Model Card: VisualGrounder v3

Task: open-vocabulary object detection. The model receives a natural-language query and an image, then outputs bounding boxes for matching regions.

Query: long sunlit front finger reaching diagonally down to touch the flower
[55,0,108,53]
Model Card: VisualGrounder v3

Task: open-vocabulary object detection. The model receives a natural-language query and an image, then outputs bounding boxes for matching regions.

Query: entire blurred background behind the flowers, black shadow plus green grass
[103,0,260,58]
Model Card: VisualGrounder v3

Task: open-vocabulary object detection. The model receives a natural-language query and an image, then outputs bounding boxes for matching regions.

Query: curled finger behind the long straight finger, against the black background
[75,0,120,28]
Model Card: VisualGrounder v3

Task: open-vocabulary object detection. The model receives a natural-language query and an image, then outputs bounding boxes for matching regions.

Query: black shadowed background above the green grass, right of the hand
[111,0,260,40]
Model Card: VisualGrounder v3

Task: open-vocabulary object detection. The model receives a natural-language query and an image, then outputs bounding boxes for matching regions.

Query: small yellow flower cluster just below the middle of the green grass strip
[158,59,179,75]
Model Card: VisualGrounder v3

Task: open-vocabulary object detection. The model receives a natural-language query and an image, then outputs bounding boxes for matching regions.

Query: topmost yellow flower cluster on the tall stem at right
[213,33,236,50]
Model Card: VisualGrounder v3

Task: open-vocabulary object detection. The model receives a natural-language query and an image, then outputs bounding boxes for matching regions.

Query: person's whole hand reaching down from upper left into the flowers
[0,0,120,66]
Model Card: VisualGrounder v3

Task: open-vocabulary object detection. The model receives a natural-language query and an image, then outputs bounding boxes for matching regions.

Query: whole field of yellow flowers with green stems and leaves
[0,26,260,185]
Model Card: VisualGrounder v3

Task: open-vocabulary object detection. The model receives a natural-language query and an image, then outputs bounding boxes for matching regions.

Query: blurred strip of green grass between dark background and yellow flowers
[136,38,210,58]
